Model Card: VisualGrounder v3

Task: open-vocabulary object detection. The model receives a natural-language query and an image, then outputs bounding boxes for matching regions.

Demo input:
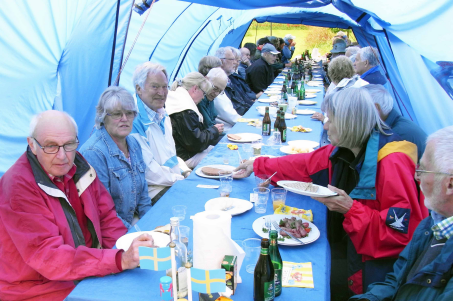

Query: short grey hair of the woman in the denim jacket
[94,86,138,129]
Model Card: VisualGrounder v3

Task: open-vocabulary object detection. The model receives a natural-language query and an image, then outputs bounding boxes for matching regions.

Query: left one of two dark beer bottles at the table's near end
[253,238,275,301]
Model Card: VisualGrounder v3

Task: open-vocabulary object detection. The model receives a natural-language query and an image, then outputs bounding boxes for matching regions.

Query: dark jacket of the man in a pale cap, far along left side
[246,57,274,93]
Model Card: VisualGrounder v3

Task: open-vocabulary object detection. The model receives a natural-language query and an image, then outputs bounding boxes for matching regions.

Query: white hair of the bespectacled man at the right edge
[425,125,453,174]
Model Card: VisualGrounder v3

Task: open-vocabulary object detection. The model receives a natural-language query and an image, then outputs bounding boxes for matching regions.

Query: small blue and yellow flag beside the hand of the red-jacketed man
[138,247,171,271]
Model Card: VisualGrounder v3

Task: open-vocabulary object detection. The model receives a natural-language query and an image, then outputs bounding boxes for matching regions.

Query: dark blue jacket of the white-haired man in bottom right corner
[350,217,453,301]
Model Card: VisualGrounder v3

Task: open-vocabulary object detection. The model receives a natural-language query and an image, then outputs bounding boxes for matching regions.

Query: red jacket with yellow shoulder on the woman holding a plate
[254,141,428,293]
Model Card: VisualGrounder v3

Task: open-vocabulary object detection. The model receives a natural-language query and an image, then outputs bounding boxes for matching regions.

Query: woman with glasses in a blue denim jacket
[80,86,151,228]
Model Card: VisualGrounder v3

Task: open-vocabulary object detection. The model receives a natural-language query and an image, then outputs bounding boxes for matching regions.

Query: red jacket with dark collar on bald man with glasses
[0,149,127,300]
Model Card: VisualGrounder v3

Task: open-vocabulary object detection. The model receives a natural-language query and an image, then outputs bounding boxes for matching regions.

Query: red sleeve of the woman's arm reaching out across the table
[253,145,335,186]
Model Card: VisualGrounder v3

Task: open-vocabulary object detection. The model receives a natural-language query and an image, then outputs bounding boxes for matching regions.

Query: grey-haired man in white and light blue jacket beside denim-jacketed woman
[132,62,191,204]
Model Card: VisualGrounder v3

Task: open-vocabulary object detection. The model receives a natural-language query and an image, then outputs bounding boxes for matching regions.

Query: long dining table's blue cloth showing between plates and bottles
[66,67,331,301]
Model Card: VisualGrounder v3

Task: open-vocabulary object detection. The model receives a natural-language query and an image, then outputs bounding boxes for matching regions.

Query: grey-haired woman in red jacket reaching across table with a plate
[235,88,428,300]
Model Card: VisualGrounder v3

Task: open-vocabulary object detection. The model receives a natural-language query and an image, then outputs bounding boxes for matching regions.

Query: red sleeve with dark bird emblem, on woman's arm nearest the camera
[343,153,428,258]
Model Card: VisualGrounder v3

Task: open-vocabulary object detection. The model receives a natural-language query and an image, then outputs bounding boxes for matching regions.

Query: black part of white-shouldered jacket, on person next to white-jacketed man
[170,110,219,161]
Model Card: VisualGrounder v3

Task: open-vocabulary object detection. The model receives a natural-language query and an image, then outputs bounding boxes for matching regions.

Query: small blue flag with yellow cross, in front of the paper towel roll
[190,268,226,294]
